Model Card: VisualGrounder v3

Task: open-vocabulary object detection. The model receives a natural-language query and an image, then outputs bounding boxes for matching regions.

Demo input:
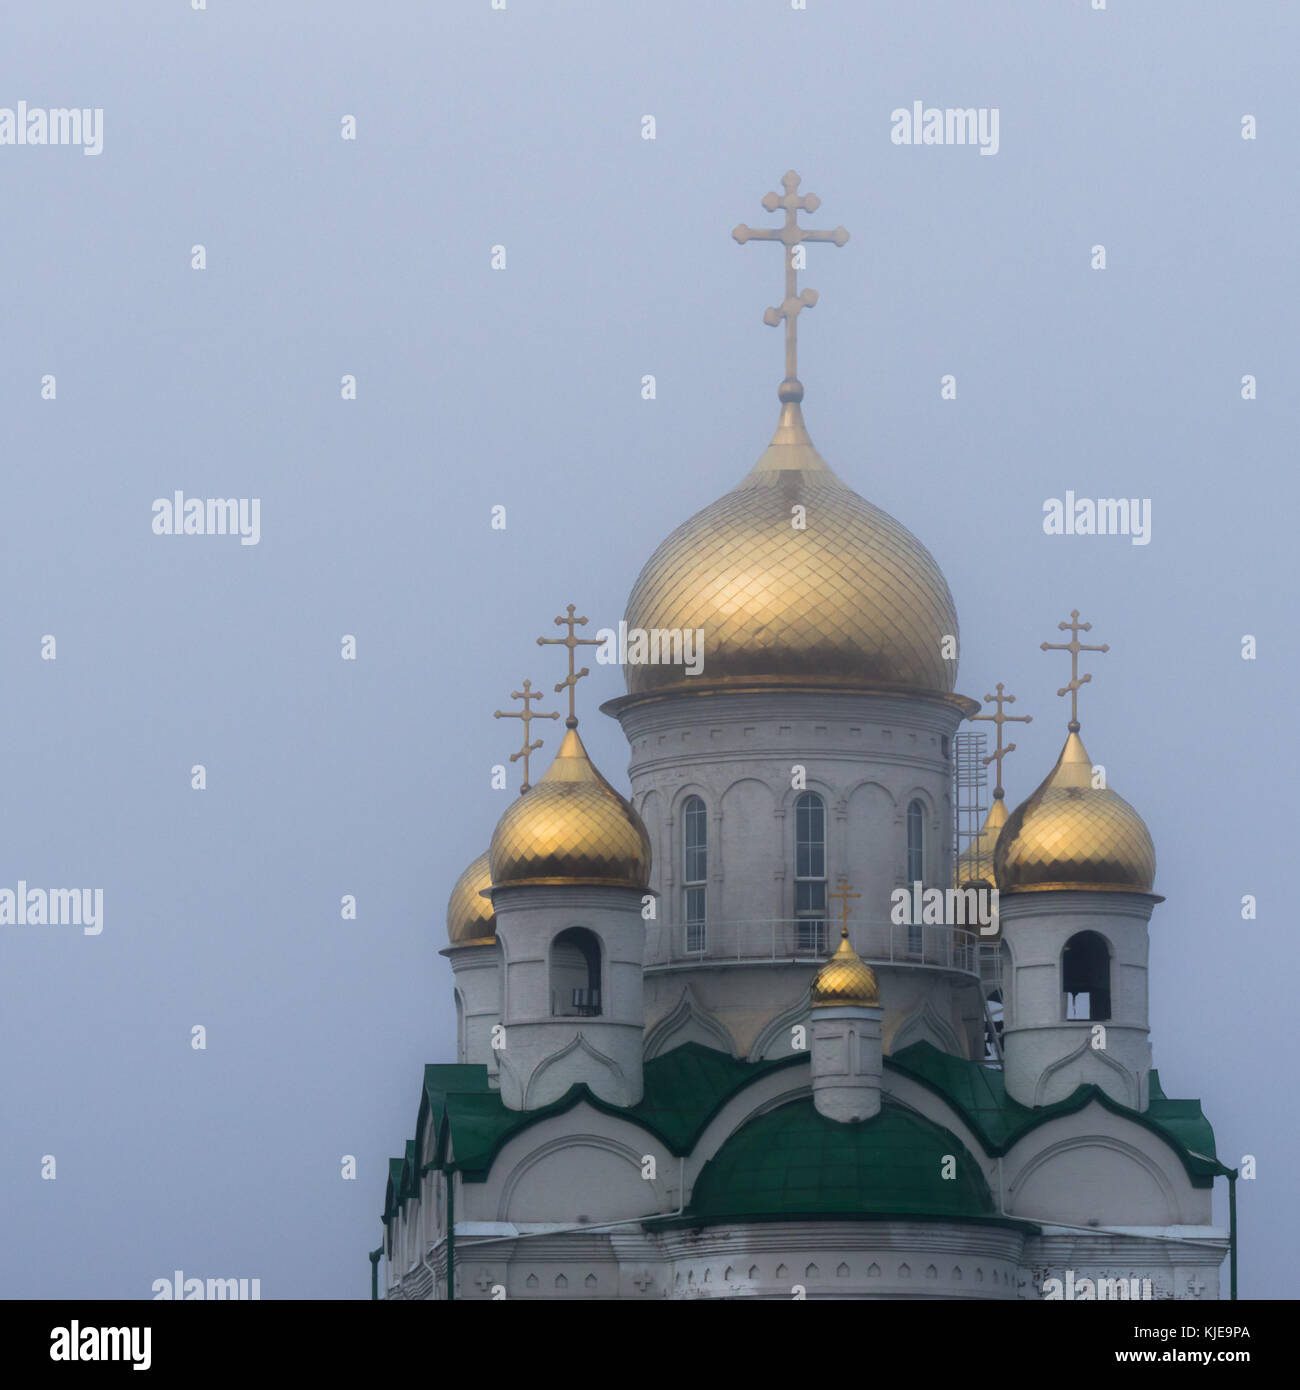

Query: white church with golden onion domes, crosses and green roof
[370,171,1236,1300]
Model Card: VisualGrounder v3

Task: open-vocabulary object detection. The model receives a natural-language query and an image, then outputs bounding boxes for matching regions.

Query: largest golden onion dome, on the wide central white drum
[624,403,977,708]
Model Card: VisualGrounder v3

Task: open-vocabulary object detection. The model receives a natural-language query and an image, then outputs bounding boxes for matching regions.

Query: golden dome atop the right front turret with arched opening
[993,733,1155,892]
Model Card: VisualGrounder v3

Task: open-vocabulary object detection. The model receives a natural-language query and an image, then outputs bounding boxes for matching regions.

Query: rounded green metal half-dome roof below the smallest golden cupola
[681,1097,994,1226]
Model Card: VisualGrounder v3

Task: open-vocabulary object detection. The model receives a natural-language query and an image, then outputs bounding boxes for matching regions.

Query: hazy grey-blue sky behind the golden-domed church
[0,0,1300,1298]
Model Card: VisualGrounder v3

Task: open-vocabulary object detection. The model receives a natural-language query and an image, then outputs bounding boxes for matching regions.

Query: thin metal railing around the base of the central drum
[647,917,989,976]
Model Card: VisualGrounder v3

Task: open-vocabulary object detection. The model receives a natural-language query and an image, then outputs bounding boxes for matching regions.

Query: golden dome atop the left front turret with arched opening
[488,728,651,888]
